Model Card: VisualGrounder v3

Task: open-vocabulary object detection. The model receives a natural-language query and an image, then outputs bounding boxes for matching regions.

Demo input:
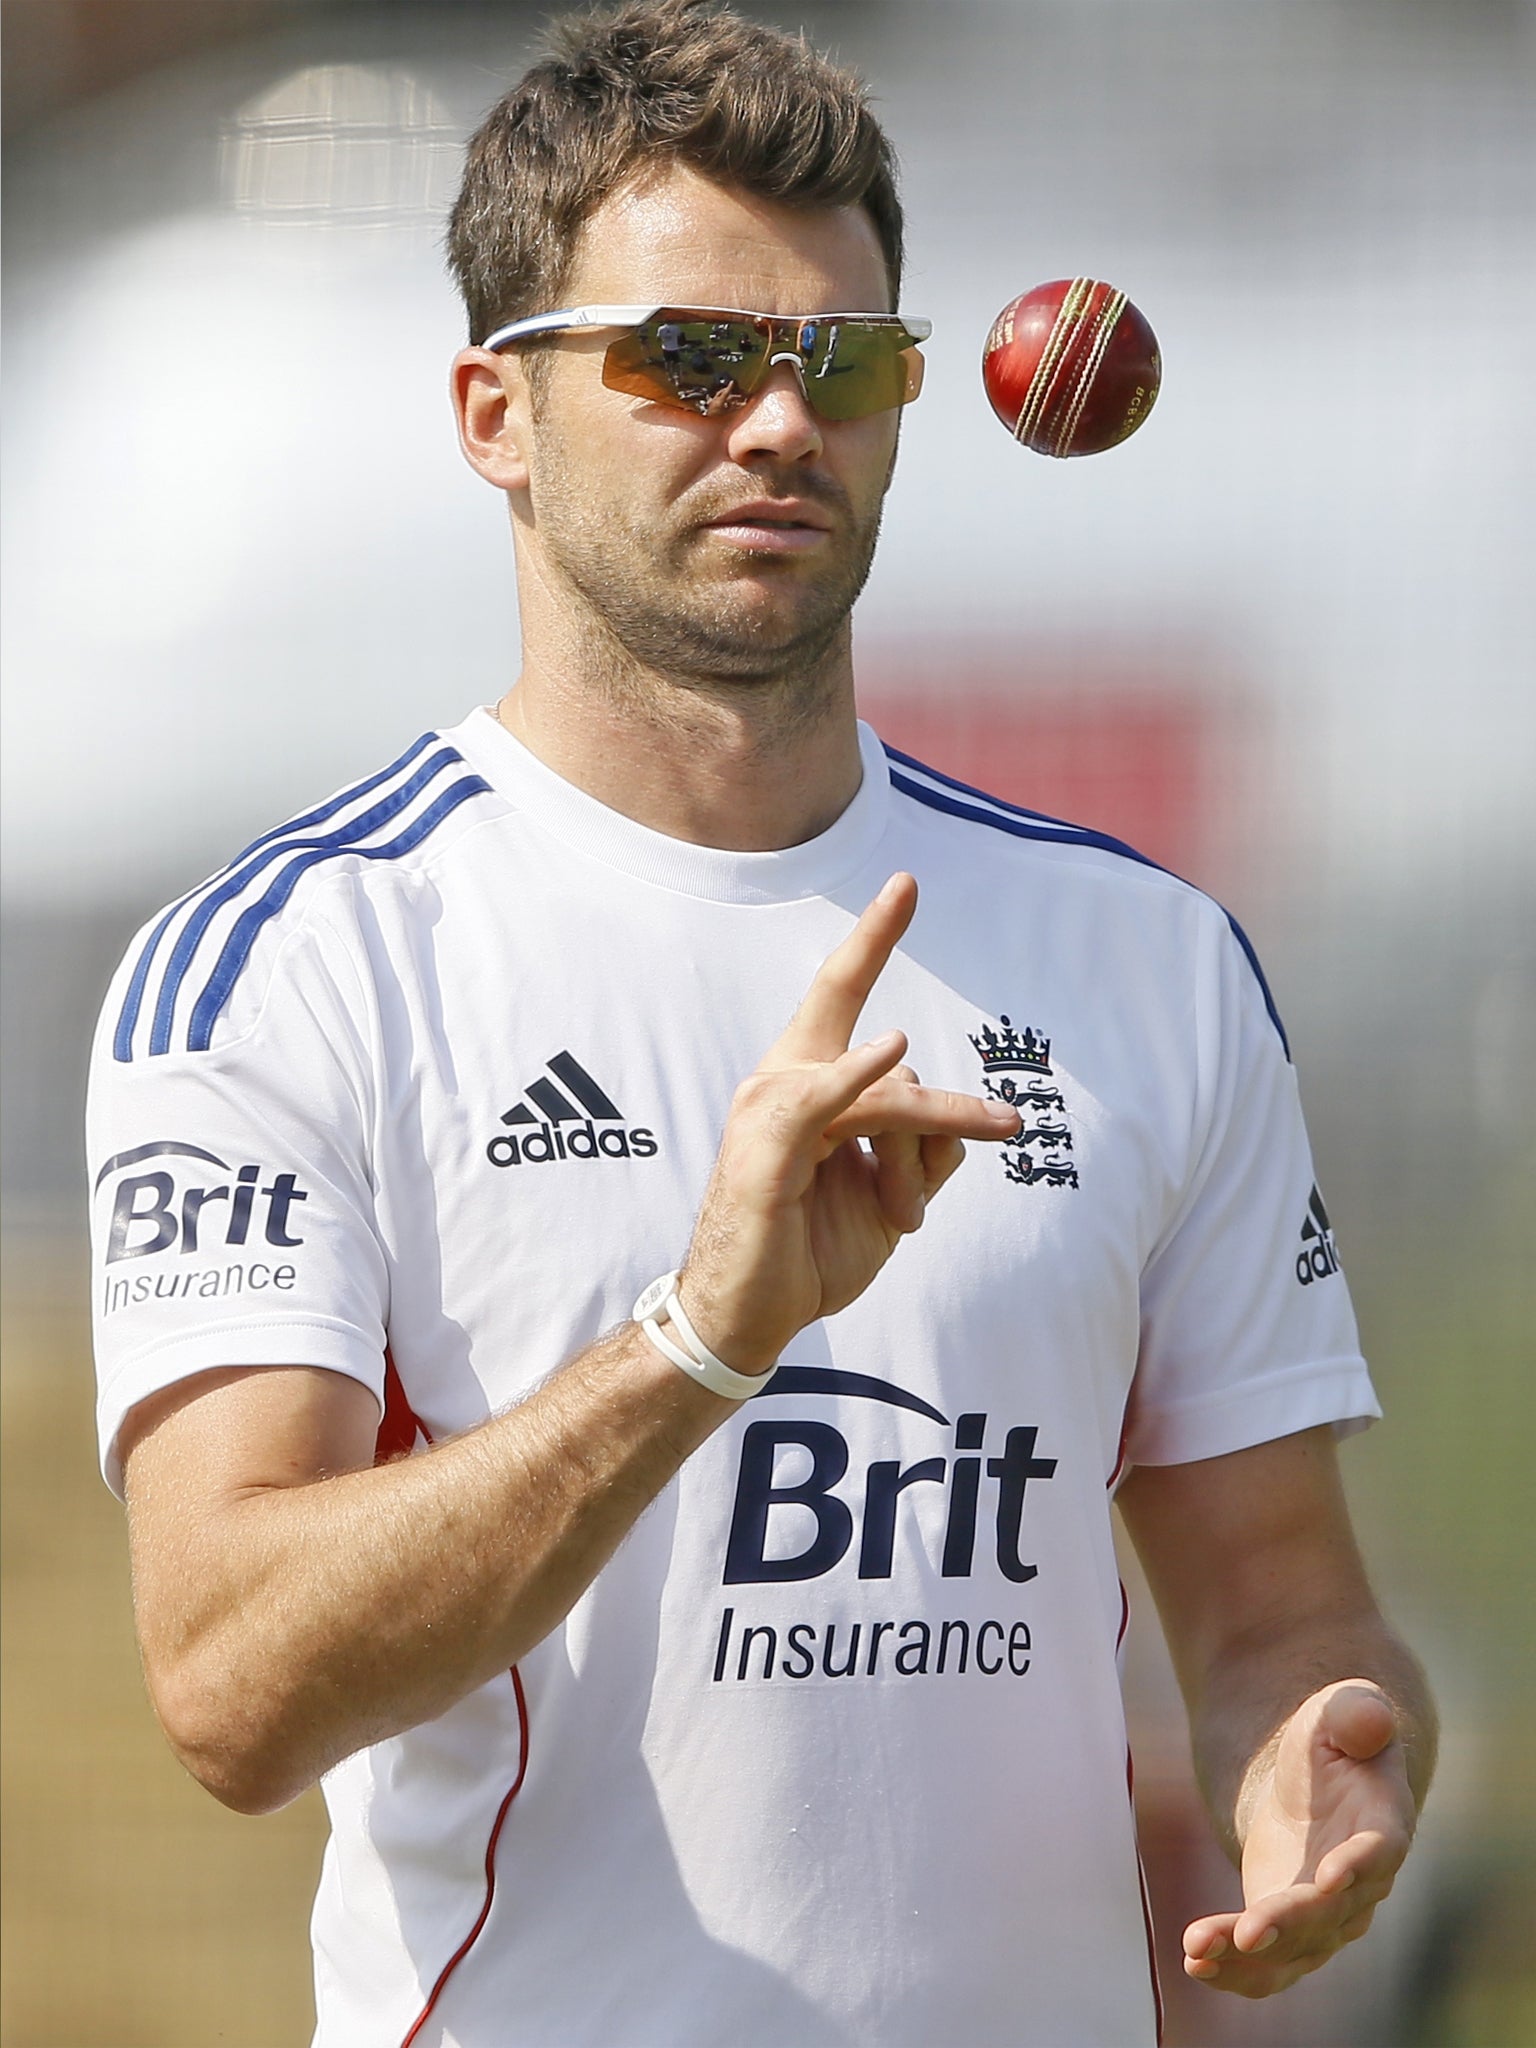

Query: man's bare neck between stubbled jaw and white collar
[496,598,862,852]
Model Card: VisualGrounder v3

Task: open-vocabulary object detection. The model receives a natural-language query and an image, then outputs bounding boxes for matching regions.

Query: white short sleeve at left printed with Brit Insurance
[86,909,389,1493]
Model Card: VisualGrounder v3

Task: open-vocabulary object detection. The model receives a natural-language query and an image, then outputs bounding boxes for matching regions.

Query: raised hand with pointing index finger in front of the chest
[680,874,1018,1372]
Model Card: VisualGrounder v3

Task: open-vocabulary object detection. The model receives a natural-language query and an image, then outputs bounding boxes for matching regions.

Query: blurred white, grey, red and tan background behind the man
[0,0,1536,2048]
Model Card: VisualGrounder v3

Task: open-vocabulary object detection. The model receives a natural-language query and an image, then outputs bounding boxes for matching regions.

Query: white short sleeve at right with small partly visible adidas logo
[1126,920,1380,1464]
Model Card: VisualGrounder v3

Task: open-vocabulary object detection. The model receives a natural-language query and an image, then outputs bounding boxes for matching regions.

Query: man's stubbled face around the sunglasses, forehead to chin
[495,166,899,682]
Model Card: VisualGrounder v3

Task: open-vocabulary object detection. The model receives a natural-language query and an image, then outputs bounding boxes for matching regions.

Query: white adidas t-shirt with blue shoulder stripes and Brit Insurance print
[90,711,1376,2048]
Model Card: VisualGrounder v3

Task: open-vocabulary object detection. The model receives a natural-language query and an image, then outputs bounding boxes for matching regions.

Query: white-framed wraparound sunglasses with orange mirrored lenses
[481,305,934,420]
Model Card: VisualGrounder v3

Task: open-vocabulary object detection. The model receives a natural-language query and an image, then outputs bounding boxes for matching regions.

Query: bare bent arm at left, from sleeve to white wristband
[131,1325,729,1810]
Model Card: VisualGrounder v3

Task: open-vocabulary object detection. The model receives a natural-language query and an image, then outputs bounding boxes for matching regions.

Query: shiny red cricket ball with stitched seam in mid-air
[981,276,1163,455]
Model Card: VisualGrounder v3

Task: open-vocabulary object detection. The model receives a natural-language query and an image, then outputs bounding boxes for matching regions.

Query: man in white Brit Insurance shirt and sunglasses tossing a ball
[92,0,1432,2048]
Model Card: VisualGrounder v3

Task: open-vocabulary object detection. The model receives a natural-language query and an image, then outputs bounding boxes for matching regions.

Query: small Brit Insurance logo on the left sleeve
[92,1139,309,1315]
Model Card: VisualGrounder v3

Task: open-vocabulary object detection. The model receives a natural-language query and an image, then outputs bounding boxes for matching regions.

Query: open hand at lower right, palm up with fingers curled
[1184,1679,1413,1999]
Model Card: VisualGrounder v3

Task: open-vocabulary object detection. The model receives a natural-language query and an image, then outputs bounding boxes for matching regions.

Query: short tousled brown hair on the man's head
[449,0,901,342]
